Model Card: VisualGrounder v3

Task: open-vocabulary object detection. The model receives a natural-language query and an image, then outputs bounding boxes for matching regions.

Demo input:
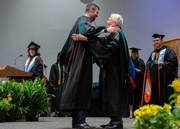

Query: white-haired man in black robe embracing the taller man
[72,14,134,128]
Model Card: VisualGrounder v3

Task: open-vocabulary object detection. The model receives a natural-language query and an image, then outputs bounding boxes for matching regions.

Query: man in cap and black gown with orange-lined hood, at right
[142,34,178,106]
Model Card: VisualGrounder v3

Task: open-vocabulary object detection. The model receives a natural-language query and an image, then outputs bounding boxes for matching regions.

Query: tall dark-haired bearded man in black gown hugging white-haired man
[60,3,119,128]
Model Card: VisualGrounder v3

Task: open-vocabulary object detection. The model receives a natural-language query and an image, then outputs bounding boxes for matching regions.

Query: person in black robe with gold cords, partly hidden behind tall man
[49,53,65,117]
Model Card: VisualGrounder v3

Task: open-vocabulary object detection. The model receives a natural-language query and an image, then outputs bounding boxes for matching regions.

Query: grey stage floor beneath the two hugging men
[0,117,135,129]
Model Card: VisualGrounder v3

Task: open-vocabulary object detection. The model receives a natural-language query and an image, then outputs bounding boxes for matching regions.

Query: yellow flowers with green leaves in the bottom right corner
[133,80,180,129]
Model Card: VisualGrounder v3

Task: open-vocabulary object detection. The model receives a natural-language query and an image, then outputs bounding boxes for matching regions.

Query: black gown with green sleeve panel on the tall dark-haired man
[60,16,103,110]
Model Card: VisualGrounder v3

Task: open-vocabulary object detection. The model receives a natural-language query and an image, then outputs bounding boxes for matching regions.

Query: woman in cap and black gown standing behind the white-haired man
[128,47,145,118]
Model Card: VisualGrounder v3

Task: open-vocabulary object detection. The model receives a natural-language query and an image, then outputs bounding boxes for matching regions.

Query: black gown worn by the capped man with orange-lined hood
[144,47,178,106]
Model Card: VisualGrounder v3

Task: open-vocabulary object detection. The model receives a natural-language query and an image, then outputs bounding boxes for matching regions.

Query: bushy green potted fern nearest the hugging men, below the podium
[22,79,50,121]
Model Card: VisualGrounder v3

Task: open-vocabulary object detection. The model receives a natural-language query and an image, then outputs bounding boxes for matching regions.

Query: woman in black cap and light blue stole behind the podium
[24,42,43,80]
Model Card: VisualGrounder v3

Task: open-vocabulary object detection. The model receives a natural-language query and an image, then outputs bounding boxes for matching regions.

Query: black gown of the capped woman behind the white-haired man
[133,58,145,110]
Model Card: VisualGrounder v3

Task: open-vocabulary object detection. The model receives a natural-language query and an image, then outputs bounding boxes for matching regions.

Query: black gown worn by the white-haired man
[88,33,128,119]
